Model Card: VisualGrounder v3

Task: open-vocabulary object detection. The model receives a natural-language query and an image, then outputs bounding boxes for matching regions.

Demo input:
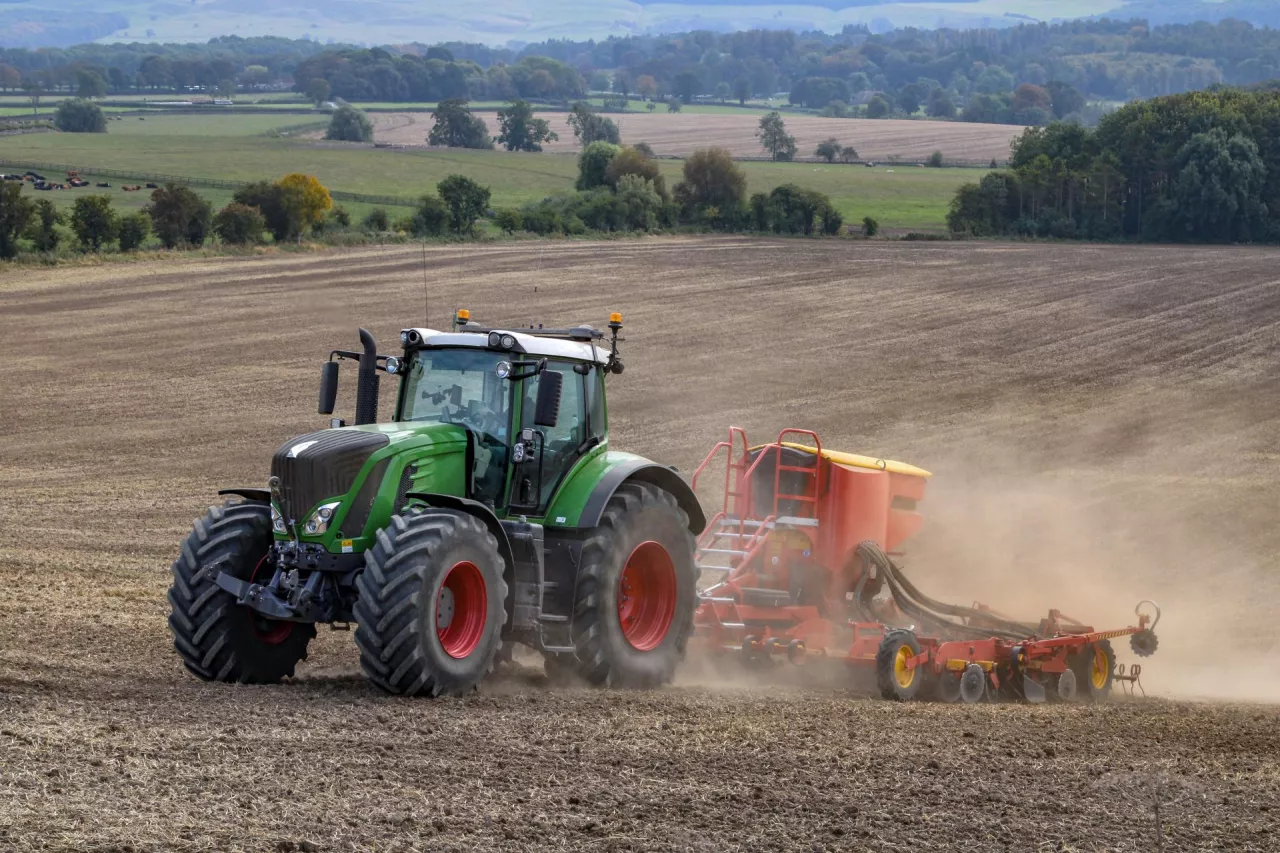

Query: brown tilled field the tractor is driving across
[0,234,1280,853]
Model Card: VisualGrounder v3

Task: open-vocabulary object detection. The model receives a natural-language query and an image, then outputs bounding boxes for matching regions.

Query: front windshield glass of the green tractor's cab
[399,350,511,444]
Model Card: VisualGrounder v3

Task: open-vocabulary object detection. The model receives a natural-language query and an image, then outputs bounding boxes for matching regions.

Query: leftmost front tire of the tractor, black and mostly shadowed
[169,501,316,684]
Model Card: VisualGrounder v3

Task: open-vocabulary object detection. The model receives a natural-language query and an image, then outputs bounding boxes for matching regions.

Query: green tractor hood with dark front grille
[271,414,467,524]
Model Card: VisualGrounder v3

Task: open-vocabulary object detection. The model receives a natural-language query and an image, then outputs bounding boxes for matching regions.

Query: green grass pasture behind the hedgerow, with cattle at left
[0,114,980,229]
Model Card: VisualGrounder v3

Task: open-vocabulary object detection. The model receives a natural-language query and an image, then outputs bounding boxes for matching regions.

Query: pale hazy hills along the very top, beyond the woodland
[0,0,1280,47]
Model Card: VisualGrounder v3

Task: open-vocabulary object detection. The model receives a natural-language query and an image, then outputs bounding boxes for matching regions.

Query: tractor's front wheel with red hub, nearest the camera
[355,510,507,697]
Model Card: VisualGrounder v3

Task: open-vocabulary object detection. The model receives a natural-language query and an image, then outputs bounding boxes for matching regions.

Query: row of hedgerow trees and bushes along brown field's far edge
[0,140,878,260]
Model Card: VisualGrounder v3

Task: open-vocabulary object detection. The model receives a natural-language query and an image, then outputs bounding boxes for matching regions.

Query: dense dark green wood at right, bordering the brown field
[947,90,1280,243]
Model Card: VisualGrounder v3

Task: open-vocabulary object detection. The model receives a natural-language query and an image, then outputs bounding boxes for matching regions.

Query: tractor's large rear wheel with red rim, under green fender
[573,482,698,688]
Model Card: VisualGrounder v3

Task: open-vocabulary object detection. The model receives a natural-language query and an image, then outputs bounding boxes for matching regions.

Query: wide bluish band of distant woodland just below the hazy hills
[0,19,1280,115]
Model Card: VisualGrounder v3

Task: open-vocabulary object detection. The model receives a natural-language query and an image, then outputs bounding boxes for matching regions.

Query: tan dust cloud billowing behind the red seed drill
[906,381,1280,702]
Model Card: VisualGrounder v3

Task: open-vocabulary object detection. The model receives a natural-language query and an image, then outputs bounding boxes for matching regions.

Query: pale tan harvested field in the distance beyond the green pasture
[370,108,1023,161]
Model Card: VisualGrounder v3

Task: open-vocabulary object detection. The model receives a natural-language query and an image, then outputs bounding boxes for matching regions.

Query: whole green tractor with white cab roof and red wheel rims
[169,311,705,695]
